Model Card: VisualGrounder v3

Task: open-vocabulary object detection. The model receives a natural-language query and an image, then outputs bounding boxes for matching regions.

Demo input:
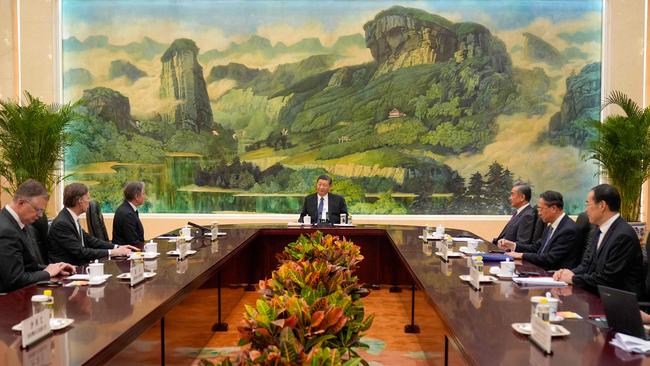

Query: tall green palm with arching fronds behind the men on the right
[589,91,650,226]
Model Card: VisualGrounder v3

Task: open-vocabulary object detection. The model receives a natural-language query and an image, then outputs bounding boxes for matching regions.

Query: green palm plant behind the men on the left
[0,92,76,194]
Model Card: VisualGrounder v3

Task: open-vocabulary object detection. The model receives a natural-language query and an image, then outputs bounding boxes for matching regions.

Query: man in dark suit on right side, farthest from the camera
[492,182,535,245]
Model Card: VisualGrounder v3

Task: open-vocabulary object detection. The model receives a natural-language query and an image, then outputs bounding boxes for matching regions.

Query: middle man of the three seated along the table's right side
[499,191,582,270]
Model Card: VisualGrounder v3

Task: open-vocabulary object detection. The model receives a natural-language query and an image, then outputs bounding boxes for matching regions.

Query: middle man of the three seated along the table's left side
[48,183,138,265]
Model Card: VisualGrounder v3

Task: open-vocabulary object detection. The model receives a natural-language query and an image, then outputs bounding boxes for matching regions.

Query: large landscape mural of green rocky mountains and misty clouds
[62,0,602,214]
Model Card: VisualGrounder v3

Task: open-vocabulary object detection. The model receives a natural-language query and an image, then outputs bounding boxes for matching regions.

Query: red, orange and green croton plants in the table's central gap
[203,231,374,366]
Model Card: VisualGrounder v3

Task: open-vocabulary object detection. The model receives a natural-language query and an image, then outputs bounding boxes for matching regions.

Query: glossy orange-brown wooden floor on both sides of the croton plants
[111,287,465,366]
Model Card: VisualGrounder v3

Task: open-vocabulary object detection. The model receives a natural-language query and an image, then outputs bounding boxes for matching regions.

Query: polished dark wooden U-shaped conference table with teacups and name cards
[0,225,650,365]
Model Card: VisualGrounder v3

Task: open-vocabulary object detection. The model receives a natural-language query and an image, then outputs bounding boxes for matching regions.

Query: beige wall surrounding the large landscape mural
[0,0,650,238]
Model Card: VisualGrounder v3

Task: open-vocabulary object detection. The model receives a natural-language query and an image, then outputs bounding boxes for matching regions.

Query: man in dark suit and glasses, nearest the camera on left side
[0,179,75,292]
